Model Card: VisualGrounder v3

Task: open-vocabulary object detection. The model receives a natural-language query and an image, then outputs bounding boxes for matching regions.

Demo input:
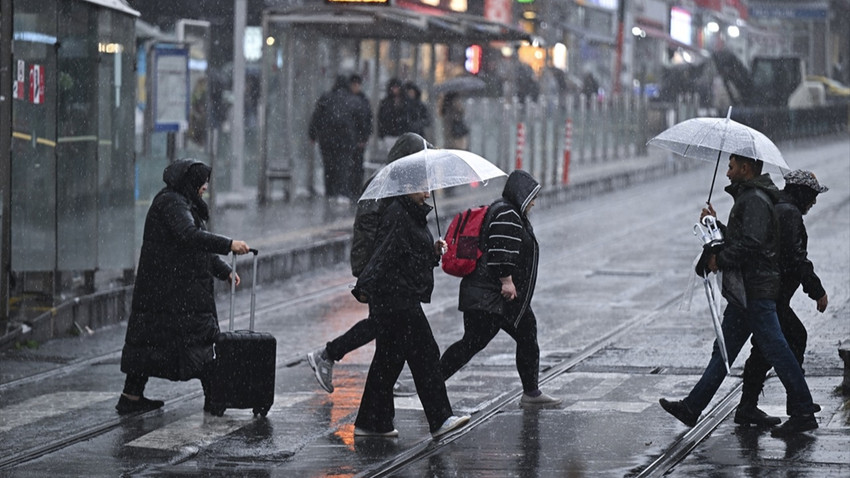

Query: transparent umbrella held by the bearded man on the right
[646,107,791,202]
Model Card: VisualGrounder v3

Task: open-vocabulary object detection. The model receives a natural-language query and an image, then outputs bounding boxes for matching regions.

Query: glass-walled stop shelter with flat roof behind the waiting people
[257,5,531,202]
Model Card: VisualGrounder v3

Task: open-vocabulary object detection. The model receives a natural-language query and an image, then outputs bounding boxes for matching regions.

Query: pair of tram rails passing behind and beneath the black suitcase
[0,281,350,470]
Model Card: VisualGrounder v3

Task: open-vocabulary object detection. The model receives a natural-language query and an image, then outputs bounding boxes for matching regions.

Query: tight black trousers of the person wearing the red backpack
[440,309,540,392]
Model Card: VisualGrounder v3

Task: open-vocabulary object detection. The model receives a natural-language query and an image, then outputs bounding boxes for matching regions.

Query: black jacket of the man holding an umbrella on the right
[717,174,779,305]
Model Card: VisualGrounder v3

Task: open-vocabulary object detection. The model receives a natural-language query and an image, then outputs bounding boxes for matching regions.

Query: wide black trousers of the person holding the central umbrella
[354,305,452,432]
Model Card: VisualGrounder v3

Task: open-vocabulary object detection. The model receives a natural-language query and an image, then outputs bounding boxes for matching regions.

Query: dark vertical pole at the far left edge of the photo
[0,0,13,337]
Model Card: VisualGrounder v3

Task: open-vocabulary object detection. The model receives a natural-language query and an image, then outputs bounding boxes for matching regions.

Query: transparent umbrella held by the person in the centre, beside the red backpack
[360,149,507,236]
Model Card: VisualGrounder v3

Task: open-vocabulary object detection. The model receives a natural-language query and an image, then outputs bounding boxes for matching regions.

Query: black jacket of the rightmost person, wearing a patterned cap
[776,194,826,303]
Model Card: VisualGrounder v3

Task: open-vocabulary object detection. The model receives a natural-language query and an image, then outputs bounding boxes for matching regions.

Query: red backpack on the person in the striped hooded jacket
[442,206,489,277]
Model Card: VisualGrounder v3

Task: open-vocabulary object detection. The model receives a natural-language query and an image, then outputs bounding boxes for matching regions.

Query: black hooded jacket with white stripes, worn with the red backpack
[458,170,540,326]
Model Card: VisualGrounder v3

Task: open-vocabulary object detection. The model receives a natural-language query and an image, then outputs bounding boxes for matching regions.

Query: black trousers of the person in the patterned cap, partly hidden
[741,298,809,407]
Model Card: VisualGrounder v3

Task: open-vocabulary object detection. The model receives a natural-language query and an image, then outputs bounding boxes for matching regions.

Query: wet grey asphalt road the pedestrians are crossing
[0,136,850,477]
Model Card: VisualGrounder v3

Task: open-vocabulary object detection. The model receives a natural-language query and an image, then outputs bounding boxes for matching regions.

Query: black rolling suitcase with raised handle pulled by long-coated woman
[208,249,277,417]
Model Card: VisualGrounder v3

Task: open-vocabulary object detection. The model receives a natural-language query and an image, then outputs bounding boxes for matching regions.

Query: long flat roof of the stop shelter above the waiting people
[264,5,531,43]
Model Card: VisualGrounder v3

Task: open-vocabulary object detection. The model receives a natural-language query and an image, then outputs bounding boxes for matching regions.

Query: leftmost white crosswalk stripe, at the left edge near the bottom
[0,391,118,433]
